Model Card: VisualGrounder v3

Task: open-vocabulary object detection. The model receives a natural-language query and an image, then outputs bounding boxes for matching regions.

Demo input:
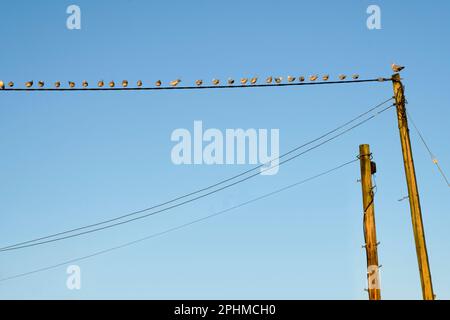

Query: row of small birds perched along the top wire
[0,74,359,89]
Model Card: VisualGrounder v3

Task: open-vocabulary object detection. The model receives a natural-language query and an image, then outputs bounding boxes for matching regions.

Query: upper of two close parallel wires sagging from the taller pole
[0,98,393,252]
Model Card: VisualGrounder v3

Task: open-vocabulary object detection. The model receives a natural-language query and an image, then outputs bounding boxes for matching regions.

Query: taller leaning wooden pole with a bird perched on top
[392,73,434,300]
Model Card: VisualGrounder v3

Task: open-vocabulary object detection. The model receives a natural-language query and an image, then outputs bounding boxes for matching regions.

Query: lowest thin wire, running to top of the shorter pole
[0,159,359,282]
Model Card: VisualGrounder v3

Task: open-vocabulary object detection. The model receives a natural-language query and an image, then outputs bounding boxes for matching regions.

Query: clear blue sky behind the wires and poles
[0,0,450,299]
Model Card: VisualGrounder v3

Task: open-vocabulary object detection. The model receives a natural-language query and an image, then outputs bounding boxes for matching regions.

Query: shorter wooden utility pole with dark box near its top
[359,144,381,300]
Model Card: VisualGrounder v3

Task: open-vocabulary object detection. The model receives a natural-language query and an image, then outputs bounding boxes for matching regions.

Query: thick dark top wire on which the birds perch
[0,78,391,92]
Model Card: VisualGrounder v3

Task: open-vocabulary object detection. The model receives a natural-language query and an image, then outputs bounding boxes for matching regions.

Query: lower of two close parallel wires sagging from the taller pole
[0,99,394,252]
